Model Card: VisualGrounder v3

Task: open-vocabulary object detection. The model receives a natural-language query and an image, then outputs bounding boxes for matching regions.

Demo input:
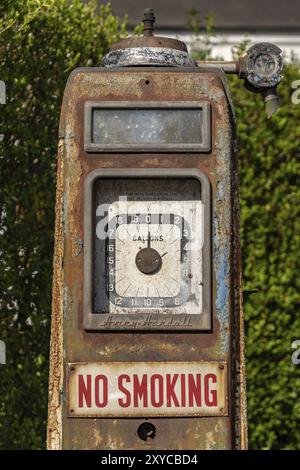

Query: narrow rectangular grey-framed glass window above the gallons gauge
[85,101,210,153]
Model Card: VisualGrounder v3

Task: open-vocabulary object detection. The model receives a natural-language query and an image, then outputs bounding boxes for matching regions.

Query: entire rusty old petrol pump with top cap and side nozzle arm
[48,9,282,450]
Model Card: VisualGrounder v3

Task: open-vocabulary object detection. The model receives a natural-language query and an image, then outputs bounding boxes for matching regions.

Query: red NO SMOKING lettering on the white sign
[77,372,218,409]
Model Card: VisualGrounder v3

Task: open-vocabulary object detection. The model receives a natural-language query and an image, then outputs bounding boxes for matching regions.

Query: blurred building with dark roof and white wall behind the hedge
[102,0,300,60]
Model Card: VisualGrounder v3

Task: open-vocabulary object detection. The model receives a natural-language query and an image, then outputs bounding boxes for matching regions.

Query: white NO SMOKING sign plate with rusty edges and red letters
[67,361,228,418]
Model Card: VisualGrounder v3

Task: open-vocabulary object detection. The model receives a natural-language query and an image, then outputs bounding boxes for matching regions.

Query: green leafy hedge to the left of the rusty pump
[0,0,126,449]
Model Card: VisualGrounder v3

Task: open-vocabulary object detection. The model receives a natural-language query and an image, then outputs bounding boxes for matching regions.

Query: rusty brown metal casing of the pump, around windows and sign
[48,67,246,450]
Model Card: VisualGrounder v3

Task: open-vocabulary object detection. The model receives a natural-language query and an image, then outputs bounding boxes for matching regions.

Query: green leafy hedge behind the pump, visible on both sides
[0,0,300,449]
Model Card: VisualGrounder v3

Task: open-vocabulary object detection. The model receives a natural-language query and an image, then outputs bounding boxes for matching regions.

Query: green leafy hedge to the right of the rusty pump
[231,67,300,449]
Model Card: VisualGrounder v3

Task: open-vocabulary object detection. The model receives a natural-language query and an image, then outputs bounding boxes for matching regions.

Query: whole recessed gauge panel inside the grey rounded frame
[93,178,210,324]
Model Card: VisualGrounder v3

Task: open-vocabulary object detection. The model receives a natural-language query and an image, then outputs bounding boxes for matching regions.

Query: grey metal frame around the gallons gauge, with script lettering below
[83,168,212,331]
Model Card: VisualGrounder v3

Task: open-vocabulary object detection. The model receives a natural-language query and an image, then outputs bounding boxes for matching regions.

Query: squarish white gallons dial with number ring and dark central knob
[106,201,201,313]
